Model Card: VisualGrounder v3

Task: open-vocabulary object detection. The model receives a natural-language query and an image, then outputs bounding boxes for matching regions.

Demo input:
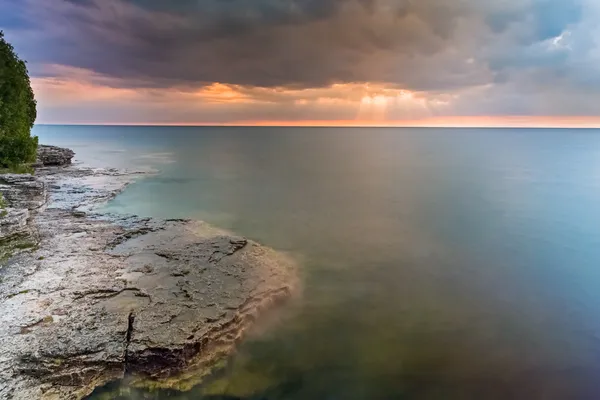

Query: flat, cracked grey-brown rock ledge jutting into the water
[0,148,297,399]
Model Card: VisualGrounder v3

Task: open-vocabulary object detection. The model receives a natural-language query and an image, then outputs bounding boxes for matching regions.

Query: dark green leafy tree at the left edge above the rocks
[0,31,38,168]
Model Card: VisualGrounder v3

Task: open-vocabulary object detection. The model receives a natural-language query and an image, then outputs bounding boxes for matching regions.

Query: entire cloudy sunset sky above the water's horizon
[0,0,600,127]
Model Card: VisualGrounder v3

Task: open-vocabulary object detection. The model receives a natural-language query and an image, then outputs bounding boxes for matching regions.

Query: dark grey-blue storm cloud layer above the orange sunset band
[0,0,600,120]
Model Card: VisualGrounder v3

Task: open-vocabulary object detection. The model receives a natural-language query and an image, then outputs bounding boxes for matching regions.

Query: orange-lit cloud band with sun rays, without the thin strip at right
[32,65,448,124]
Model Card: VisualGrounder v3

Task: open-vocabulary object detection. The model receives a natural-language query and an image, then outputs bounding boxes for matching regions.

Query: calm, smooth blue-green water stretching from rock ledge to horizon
[35,126,600,400]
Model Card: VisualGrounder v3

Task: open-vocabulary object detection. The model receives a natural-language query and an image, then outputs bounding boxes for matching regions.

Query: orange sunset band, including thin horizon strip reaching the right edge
[32,65,600,128]
